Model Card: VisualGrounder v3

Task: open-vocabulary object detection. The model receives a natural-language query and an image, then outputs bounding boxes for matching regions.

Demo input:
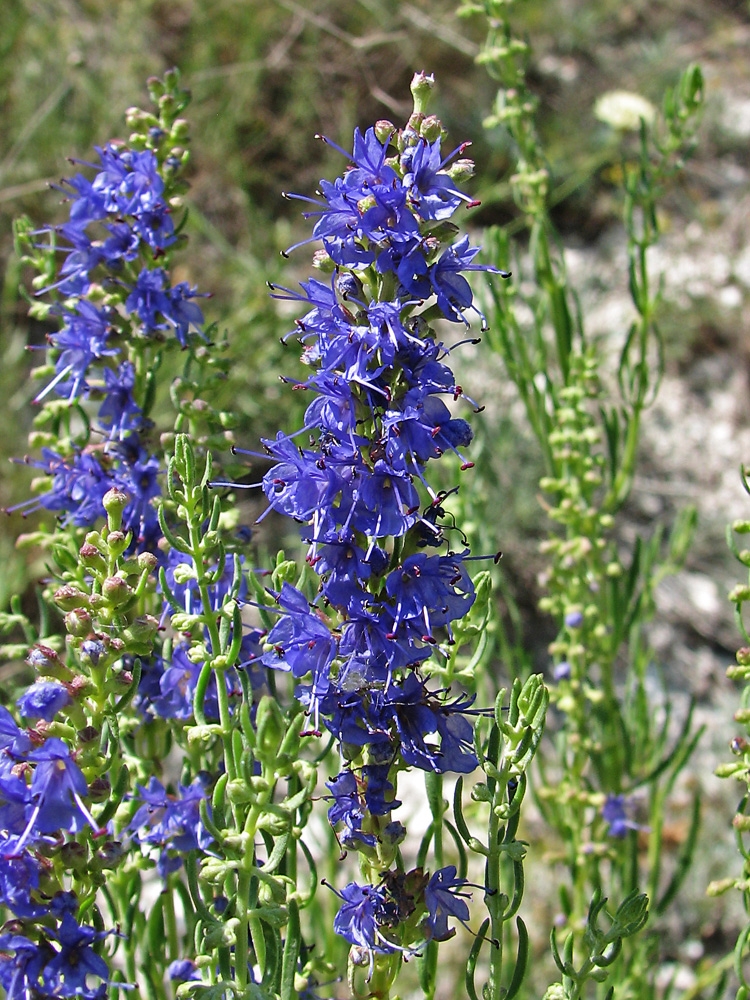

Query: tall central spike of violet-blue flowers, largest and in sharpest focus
[236,74,512,968]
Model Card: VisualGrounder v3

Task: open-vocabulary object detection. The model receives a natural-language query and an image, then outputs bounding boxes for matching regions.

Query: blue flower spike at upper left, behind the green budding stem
[12,95,203,551]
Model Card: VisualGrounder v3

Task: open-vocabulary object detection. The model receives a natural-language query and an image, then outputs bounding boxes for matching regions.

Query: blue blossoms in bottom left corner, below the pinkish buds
[0,708,117,998]
